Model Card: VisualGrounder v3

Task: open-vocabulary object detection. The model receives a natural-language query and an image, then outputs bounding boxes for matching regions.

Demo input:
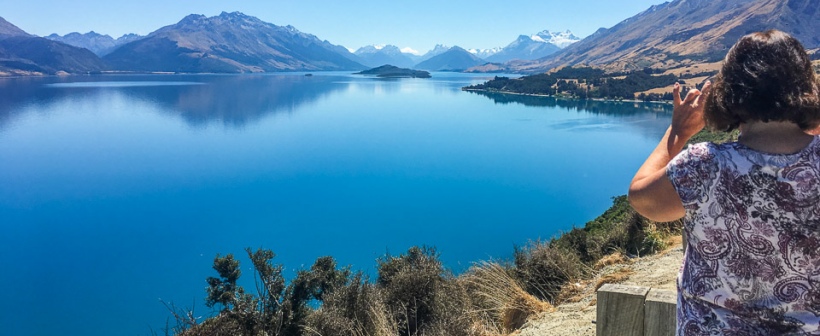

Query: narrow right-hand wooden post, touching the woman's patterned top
[644,288,678,336]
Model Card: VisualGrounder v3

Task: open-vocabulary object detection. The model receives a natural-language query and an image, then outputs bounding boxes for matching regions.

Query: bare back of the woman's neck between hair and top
[738,121,814,154]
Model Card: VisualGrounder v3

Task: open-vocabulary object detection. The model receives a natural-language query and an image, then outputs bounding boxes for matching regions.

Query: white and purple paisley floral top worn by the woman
[666,137,820,335]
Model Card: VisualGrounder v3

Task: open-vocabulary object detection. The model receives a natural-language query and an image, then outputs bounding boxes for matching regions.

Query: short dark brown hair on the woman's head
[704,30,820,131]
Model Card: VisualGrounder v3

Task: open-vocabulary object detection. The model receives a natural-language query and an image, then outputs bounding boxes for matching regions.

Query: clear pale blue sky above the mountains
[0,0,664,52]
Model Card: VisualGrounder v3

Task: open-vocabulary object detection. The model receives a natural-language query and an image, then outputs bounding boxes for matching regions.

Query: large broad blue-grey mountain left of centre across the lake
[103,12,366,72]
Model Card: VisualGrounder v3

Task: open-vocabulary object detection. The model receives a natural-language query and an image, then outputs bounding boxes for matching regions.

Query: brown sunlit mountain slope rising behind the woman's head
[510,0,820,72]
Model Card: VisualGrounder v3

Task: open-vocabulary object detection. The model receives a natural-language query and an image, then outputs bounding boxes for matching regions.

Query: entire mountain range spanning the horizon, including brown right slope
[0,0,820,75]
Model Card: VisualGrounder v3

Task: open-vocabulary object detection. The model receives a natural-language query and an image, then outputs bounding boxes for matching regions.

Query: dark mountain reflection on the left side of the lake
[0,74,349,130]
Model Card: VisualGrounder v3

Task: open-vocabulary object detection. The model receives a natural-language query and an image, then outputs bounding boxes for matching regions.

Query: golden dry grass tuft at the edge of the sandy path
[465,261,555,332]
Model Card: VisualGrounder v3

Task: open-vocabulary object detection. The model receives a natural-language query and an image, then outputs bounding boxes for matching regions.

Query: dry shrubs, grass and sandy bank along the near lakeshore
[165,131,736,336]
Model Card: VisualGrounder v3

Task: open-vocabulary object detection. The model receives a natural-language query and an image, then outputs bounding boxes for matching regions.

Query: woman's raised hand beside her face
[672,81,712,142]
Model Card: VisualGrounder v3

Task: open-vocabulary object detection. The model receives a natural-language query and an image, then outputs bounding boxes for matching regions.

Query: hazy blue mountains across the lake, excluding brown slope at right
[0,12,577,75]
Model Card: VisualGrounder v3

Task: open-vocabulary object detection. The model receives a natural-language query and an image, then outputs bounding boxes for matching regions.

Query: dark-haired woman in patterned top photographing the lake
[629,30,820,335]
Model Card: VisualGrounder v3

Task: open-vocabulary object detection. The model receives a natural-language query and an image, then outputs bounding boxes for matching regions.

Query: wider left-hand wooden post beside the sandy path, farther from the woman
[595,284,649,336]
